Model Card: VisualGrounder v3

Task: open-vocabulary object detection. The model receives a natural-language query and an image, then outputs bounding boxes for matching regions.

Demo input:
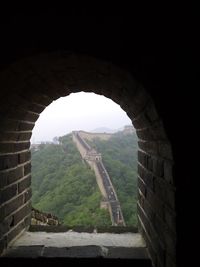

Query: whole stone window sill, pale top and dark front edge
[1,230,151,266]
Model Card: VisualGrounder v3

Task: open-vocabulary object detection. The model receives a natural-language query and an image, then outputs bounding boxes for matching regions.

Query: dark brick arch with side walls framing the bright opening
[0,52,176,266]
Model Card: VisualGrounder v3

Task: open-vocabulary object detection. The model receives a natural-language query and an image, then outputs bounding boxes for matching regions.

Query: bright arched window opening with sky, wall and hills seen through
[31,92,137,231]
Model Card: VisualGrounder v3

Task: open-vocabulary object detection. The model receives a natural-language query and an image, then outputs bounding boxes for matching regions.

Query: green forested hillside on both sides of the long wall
[32,133,137,226]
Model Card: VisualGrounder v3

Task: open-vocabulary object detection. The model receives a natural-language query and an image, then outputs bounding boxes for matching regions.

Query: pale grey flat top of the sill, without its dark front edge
[8,231,146,248]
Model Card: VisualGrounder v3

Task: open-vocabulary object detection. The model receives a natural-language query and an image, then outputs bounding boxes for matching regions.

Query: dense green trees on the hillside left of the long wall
[32,135,111,226]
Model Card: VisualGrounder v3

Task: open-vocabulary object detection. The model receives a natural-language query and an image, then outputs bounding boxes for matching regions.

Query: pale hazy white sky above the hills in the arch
[31,92,132,142]
